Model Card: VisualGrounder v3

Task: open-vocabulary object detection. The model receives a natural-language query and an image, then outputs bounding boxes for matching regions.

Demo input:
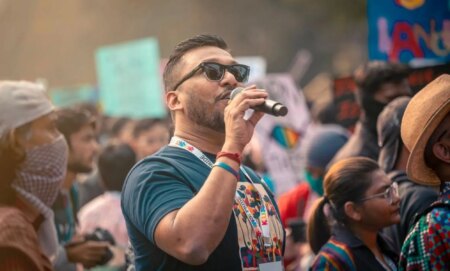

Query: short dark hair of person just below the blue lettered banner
[353,61,410,96]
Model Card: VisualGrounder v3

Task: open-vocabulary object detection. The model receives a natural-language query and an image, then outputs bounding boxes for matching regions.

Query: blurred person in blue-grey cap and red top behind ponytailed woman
[278,124,349,270]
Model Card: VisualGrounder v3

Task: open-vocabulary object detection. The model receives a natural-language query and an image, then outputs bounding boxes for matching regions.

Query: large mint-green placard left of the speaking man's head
[96,38,167,118]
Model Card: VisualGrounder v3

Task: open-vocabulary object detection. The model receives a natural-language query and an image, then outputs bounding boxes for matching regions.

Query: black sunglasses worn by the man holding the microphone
[173,62,250,90]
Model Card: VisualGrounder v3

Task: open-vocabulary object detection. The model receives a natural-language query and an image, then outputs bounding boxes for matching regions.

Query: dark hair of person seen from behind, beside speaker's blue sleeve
[98,144,136,191]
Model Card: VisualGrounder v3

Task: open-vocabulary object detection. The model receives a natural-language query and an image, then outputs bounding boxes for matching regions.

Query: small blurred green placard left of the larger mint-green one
[49,85,98,107]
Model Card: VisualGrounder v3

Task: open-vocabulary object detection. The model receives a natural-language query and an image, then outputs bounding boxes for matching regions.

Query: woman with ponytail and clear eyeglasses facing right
[307,157,400,270]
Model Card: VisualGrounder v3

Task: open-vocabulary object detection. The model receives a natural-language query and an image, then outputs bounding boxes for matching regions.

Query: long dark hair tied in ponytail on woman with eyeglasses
[308,157,380,254]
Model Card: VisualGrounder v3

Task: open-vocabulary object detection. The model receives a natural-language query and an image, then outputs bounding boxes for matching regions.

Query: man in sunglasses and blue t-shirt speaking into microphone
[122,35,284,271]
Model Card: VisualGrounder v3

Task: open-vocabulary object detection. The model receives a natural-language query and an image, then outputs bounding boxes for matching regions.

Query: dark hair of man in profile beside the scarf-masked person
[56,108,95,147]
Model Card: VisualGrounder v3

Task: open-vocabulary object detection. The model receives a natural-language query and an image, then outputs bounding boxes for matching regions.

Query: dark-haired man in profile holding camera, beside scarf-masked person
[53,108,108,270]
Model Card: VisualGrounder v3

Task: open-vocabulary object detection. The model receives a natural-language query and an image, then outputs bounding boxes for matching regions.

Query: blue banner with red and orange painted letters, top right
[367,0,450,66]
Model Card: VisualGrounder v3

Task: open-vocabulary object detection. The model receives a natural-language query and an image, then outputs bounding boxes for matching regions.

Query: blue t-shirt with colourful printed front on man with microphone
[121,146,284,271]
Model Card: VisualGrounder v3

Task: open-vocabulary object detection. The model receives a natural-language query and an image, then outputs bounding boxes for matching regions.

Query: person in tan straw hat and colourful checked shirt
[399,74,450,270]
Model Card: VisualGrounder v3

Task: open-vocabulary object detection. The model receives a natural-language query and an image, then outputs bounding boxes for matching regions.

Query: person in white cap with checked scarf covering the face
[0,81,68,270]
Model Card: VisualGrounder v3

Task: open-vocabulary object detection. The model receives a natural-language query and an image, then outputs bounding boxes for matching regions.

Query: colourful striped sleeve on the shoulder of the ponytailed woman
[310,238,356,271]
